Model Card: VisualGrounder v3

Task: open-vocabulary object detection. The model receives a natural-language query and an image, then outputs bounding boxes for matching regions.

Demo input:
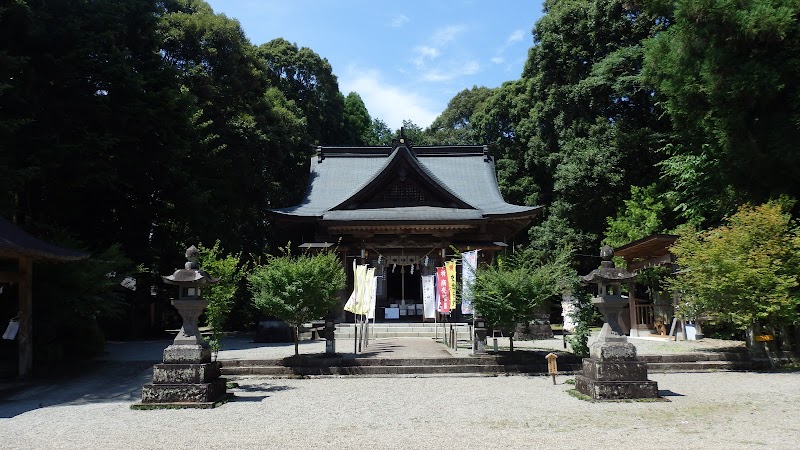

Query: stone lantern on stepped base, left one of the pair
[134,246,226,408]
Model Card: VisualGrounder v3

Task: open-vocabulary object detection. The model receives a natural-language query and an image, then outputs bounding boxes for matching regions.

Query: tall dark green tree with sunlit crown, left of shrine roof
[157,0,310,253]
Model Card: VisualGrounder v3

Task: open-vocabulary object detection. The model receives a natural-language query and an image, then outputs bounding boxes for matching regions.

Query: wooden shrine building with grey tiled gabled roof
[271,131,541,320]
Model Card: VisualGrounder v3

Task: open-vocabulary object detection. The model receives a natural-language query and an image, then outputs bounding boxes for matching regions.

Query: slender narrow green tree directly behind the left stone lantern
[198,240,248,352]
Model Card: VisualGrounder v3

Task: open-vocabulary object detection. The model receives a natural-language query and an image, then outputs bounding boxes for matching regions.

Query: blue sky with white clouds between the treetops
[206,0,542,129]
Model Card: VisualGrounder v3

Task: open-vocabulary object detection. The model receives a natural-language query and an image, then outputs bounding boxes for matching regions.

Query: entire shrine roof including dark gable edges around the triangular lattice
[273,144,541,222]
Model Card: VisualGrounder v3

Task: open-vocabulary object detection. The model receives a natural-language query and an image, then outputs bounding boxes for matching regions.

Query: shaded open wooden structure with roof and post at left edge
[0,217,89,377]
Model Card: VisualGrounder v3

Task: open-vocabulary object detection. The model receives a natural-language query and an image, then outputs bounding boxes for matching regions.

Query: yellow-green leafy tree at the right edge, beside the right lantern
[668,201,800,330]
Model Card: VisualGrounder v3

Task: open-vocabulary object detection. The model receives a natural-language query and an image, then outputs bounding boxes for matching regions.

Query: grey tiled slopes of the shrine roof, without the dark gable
[274,146,539,221]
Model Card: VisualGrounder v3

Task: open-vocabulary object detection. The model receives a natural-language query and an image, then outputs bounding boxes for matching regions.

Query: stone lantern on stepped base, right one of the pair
[575,246,658,400]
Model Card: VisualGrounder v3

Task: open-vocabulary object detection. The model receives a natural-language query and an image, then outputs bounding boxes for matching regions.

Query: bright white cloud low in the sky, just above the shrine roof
[339,67,440,130]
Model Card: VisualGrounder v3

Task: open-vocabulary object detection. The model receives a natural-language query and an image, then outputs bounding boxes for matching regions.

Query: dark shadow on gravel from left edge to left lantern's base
[0,361,156,419]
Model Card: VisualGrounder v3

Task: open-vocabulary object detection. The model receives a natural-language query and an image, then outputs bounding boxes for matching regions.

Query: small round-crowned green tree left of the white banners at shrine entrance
[247,249,345,355]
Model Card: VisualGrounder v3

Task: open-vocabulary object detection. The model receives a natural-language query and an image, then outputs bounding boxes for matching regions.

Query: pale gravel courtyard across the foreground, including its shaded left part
[0,368,800,449]
